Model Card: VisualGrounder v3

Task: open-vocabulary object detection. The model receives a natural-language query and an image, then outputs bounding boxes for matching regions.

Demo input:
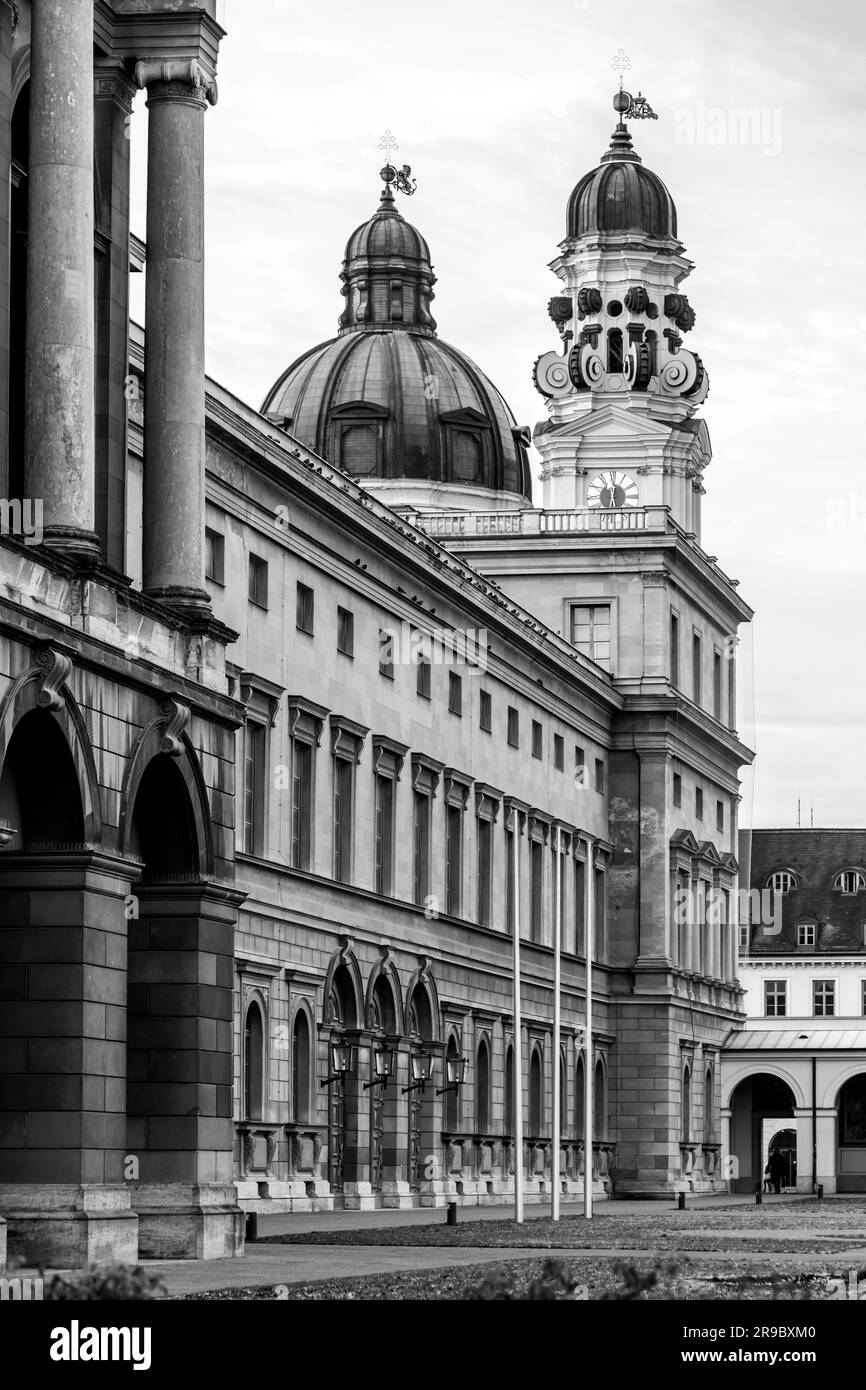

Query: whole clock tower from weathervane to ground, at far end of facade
[449,90,752,1197]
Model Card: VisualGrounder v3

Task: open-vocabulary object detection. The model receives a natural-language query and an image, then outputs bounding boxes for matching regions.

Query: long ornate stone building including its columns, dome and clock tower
[0,0,751,1265]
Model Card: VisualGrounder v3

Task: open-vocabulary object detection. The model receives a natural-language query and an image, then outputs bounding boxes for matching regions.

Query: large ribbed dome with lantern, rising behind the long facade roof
[263,167,531,509]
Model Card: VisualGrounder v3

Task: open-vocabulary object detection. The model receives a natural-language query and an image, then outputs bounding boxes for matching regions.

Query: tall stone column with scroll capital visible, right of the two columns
[135,58,217,617]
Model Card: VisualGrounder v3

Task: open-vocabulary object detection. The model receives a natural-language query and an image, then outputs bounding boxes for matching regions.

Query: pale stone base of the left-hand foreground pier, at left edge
[0,1183,139,1269]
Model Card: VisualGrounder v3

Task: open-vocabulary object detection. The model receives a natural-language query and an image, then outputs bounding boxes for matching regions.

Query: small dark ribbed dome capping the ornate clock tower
[567,122,677,240]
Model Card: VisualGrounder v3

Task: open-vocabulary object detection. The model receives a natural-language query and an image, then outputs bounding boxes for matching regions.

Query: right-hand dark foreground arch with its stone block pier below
[121,745,241,1259]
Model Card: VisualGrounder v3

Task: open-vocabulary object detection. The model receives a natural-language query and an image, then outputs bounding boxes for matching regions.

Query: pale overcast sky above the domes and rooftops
[133,0,866,826]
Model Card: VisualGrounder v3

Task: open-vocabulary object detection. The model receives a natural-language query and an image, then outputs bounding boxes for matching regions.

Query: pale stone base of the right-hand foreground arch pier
[131,1183,245,1259]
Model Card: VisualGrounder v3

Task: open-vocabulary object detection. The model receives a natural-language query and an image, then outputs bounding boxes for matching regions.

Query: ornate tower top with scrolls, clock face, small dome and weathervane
[535,88,710,537]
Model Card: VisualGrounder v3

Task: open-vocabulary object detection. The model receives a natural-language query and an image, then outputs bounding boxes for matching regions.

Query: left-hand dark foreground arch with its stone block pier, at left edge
[0,711,138,1268]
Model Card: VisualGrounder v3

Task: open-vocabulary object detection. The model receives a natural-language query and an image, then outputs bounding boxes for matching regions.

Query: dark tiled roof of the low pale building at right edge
[738,830,866,955]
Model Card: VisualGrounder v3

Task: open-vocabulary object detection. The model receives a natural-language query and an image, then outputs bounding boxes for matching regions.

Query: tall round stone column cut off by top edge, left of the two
[24,0,99,557]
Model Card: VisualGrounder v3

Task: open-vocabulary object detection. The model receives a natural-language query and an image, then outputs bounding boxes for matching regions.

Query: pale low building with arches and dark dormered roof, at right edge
[721,828,866,1193]
